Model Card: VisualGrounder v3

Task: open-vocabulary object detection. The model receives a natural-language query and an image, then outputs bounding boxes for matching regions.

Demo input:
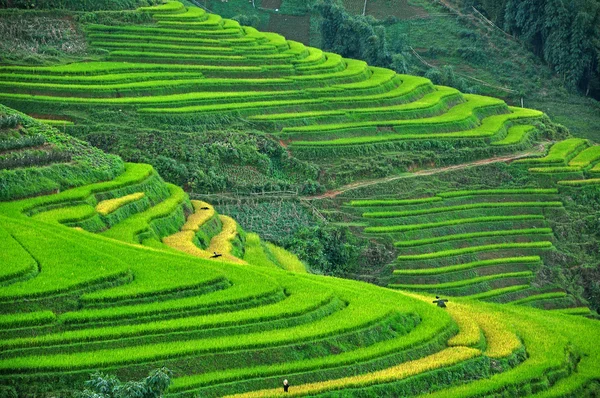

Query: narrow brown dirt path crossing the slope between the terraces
[305,144,549,200]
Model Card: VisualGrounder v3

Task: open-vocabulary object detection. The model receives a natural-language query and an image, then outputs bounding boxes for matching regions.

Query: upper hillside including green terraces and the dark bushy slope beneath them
[0,1,553,193]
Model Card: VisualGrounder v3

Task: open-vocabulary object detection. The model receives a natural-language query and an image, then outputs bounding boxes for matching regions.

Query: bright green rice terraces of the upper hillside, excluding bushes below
[0,1,547,190]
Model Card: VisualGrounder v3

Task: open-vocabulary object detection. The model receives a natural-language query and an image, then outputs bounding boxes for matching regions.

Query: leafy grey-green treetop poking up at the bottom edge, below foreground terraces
[76,367,173,398]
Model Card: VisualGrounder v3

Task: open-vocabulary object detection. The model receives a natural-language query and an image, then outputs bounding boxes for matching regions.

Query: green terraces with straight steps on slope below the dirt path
[317,138,600,309]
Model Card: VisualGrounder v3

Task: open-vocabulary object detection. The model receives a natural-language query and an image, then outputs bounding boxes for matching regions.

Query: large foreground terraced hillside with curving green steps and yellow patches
[0,108,600,397]
